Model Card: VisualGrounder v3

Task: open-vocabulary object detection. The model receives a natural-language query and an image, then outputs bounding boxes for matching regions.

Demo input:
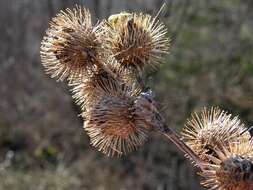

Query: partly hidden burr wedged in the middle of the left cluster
[69,61,141,111]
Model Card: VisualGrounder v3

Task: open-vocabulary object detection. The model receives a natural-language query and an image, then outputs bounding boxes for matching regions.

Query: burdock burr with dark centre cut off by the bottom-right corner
[201,137,253,190]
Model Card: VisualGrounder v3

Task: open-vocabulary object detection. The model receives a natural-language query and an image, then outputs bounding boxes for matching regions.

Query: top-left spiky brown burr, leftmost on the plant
[41,6,102,80]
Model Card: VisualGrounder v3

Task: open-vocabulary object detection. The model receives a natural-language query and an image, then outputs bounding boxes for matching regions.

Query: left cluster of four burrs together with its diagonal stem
[41,6,206,171]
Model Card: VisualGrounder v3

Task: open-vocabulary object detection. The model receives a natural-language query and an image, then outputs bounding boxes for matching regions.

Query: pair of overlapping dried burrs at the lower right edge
[182,107,253,190]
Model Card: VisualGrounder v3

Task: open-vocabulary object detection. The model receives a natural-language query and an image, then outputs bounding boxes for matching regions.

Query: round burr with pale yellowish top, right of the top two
[102,12,169,72]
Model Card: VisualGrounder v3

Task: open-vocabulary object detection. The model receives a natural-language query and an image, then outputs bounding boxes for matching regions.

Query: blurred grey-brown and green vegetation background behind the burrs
[0,0,253,190]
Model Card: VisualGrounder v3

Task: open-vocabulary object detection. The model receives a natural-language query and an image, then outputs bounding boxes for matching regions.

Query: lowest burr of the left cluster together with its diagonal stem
[83,87,207,167]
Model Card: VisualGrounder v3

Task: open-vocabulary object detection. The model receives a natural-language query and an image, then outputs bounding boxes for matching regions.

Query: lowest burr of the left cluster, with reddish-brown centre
[83,89,151,156]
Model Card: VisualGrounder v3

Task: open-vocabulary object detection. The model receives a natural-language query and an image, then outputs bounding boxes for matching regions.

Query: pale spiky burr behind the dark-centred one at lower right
[182,107,248,161]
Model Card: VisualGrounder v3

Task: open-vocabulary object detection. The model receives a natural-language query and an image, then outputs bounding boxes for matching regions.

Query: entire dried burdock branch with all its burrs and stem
[41,6,253,190]
